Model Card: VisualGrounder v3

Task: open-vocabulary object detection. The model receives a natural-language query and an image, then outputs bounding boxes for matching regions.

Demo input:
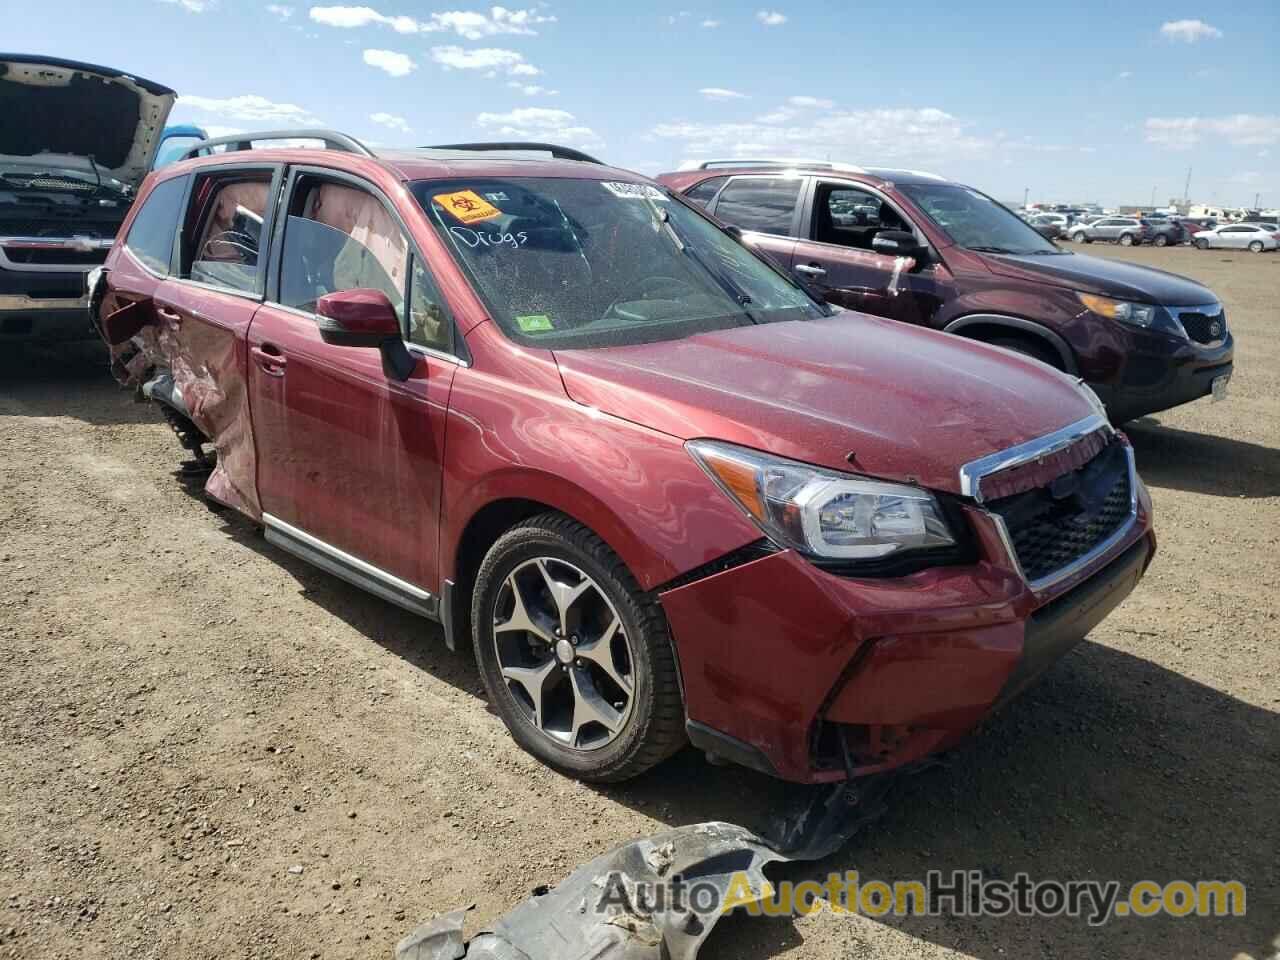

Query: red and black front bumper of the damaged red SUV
[660,485,1155,783]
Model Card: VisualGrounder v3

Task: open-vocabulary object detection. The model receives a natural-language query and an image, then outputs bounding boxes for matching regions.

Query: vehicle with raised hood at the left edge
[0,54,177,342]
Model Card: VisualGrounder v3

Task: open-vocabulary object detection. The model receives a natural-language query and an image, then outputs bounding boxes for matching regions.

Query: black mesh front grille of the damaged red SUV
[988,442,1133,582]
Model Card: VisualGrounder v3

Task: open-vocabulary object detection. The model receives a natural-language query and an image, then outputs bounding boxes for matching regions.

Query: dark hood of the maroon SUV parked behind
[984,253,1217,307]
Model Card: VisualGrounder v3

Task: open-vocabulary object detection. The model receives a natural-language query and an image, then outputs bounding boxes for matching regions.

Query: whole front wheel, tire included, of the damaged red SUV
[471,513,685,783]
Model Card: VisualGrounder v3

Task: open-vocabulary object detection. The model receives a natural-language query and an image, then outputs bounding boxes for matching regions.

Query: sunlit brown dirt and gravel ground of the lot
[0,244,1280,960]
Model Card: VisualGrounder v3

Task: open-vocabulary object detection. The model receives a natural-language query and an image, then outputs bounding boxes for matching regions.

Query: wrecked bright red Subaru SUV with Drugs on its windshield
[91,132,1155,782]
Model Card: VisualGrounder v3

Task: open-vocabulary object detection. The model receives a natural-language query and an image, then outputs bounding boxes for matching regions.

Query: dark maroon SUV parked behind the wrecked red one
[658,160,1234,424]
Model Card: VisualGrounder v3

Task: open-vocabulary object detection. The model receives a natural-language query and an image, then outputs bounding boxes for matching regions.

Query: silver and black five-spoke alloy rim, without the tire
[493,557,635,751]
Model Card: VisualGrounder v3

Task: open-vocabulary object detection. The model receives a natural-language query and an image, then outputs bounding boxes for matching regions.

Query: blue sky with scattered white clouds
[10,0,1280,207]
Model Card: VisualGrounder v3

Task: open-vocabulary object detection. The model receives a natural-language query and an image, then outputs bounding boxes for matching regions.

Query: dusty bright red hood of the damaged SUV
[556,312,1093,493]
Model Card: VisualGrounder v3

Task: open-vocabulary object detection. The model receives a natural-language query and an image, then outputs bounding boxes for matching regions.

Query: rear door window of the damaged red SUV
[182,170,273,293]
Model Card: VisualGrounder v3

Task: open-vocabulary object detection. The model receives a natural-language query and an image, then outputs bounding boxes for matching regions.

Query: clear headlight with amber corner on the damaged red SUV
[685,440,955,559]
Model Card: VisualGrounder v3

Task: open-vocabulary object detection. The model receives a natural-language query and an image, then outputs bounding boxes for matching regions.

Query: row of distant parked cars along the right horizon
[1024,214,1280,253]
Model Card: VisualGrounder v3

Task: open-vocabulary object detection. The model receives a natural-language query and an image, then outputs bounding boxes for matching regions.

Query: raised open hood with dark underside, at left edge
[0,54,178,189]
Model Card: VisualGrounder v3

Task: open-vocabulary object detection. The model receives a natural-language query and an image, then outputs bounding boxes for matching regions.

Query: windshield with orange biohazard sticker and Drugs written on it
[411,177,829,348]
